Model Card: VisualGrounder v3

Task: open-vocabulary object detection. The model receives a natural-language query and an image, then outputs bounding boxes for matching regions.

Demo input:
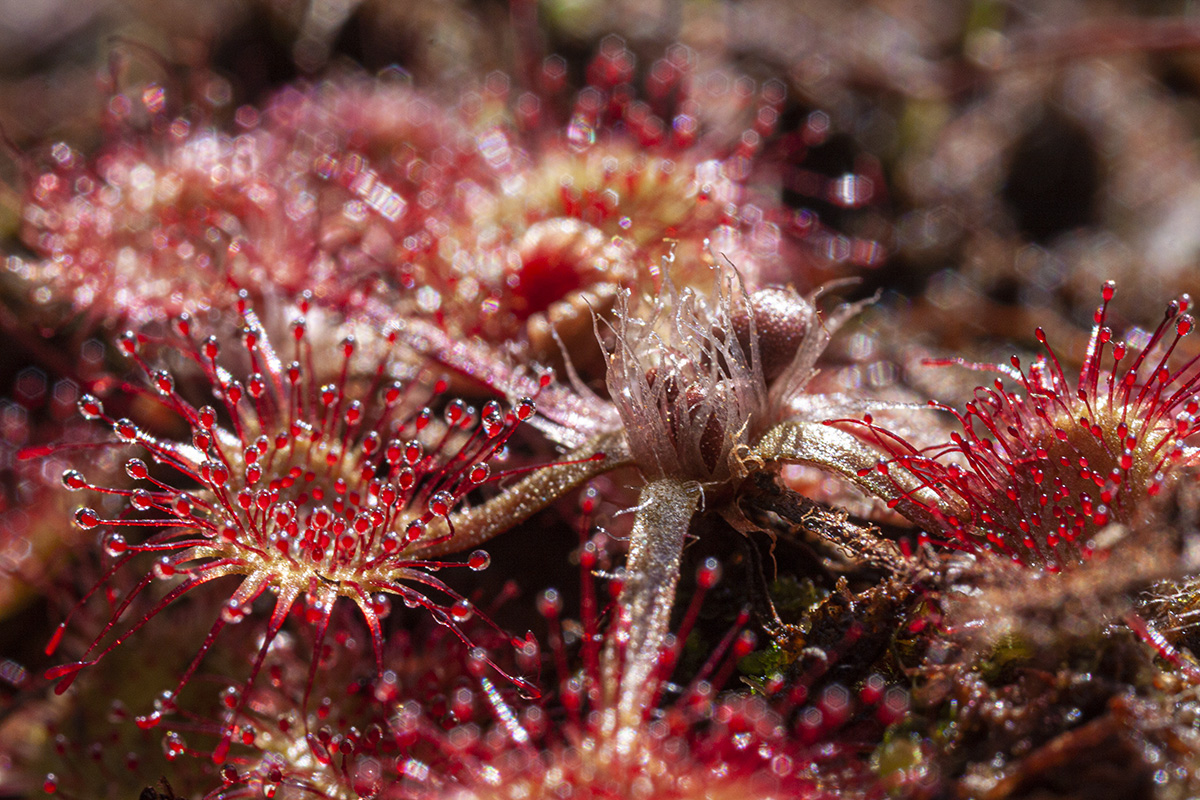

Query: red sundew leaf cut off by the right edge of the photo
[844,282,1200,570]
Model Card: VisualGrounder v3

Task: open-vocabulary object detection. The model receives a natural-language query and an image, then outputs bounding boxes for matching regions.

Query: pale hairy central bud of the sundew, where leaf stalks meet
[607,261,863,485]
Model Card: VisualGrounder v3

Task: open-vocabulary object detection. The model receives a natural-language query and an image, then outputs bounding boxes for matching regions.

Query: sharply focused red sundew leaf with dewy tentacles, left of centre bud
[47,293,534,760]
